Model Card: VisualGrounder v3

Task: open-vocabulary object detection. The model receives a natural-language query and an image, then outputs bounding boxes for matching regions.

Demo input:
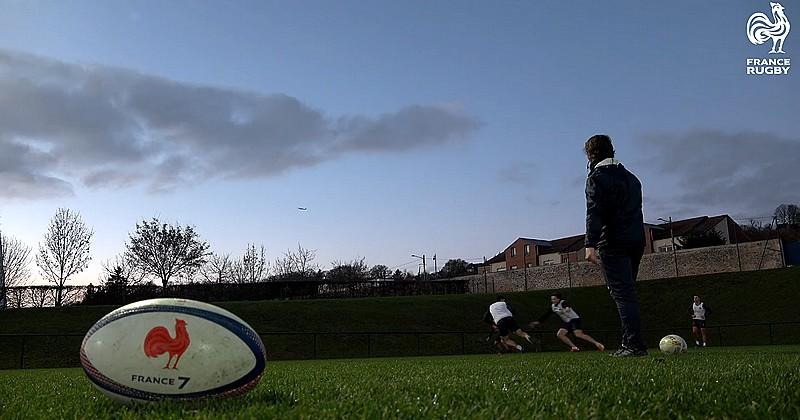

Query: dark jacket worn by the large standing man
[586,159,645,249]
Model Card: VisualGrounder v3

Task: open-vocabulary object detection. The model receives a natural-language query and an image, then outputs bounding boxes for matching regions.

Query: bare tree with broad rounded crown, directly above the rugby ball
[125,218,209,288]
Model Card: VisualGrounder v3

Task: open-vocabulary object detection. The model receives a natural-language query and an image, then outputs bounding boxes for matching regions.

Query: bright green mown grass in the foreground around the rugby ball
[0,346,800,419]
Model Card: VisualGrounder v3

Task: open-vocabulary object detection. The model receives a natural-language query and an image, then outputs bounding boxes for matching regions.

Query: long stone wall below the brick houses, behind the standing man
[461,239,784,293]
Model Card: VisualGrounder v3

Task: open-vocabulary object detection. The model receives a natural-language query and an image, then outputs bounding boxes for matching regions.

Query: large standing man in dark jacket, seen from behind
[583,134,647,357]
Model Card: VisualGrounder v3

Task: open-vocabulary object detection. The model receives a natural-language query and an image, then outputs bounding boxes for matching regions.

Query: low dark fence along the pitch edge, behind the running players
[0,321,800,369]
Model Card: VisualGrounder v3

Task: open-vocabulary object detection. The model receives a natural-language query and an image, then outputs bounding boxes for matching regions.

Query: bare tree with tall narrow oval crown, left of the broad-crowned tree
[36,208,94,306]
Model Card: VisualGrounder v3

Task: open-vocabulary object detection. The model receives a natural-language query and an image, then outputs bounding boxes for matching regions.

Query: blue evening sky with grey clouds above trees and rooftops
[0,0,800,284]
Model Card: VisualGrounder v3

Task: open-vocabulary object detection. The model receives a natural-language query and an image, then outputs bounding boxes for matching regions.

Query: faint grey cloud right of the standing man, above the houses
[641,130,800,217]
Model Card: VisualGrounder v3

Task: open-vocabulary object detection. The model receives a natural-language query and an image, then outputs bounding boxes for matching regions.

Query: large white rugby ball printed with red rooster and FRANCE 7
[80,299,266,403]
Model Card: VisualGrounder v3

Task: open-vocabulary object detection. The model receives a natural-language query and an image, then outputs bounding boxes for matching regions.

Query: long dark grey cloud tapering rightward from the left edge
[0,50,480,198]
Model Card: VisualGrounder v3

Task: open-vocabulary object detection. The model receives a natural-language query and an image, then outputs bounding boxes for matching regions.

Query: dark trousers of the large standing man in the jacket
[598,246,647,350]
